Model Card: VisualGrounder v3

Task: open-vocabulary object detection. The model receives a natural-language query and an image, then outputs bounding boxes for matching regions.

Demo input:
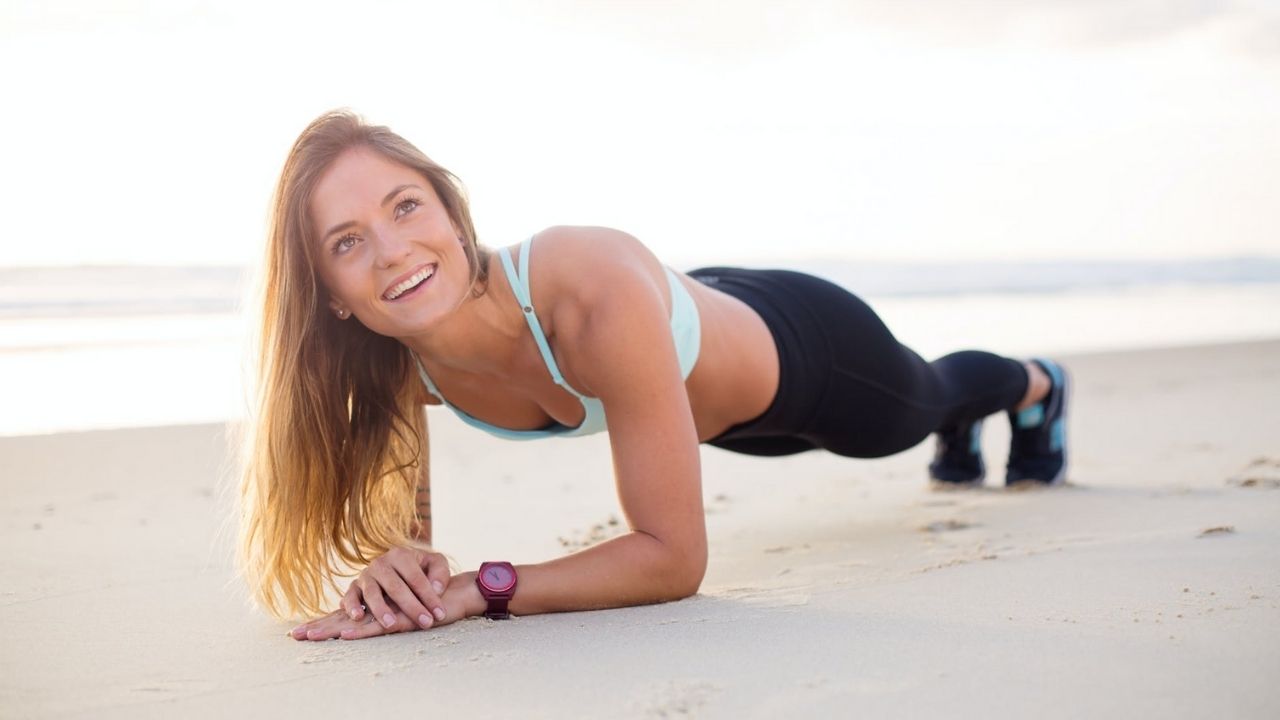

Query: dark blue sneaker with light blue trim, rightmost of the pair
[1005,357,1070,486]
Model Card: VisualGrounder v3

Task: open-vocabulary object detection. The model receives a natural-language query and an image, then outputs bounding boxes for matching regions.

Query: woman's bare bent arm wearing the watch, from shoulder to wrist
[494,229,707,615]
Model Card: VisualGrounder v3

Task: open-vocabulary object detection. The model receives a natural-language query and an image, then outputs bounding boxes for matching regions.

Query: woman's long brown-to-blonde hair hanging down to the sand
[241,110,489,616]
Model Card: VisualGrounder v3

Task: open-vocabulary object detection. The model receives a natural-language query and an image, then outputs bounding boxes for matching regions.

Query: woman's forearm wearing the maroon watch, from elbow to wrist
[451,532,707,615]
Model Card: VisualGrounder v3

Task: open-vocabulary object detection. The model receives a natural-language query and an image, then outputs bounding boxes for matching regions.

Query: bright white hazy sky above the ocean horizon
[0,0,1280,266]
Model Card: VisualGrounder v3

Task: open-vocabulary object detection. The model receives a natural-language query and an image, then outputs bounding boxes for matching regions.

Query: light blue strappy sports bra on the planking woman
[413,237,701,439]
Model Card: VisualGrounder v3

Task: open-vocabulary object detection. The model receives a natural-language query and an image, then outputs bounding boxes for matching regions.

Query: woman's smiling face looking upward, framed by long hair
[310,147,471,337]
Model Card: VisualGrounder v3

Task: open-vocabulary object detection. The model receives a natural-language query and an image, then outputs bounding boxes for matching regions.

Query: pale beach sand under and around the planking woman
[0,341,1280,717]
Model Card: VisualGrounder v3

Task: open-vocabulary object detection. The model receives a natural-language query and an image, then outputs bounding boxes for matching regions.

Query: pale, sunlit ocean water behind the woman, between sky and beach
[0,258,1280,436]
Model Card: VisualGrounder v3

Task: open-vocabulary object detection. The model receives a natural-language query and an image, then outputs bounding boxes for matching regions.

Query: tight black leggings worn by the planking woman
[689,268,1027,457]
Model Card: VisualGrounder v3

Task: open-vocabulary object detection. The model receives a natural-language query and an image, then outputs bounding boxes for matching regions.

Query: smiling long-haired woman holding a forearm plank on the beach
[242,111,1068,639]
